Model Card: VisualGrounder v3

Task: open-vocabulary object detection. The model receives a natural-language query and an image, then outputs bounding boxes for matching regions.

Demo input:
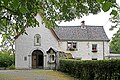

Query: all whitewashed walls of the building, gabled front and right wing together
[15,15,109,69]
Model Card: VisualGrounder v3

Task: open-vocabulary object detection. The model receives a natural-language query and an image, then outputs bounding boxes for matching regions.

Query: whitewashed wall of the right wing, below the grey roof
[59,41,109,60]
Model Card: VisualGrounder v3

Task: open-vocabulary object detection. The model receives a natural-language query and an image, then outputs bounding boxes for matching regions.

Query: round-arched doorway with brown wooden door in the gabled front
[32,50,44,69]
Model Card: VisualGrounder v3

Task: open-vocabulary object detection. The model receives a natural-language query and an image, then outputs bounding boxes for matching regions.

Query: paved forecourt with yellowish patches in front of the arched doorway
[0,70,75,80]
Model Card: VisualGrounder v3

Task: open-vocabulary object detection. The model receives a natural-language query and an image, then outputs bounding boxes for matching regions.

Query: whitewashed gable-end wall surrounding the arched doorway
[15,15,59,68]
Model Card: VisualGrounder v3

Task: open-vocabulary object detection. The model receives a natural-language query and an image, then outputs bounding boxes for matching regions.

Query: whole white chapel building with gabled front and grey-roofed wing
[15,15,109,69]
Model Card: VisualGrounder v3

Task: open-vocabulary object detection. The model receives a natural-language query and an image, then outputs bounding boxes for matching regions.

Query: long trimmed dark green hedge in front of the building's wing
[60,59,120,80]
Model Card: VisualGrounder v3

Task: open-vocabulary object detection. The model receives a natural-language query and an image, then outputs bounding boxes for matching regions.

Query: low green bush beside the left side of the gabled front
[0,51,14,67]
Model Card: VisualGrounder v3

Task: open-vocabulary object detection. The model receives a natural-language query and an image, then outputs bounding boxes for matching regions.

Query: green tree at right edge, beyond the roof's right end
[110,28,120,53]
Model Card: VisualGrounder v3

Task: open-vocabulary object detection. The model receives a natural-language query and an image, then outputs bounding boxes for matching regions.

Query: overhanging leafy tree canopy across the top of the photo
[0,0,117,44]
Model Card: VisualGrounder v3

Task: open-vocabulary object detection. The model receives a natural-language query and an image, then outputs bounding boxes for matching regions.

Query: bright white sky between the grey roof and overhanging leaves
[59,0,120,39]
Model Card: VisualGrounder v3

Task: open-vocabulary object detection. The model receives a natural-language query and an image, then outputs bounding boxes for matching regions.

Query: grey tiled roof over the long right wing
[53,25,109,41]
